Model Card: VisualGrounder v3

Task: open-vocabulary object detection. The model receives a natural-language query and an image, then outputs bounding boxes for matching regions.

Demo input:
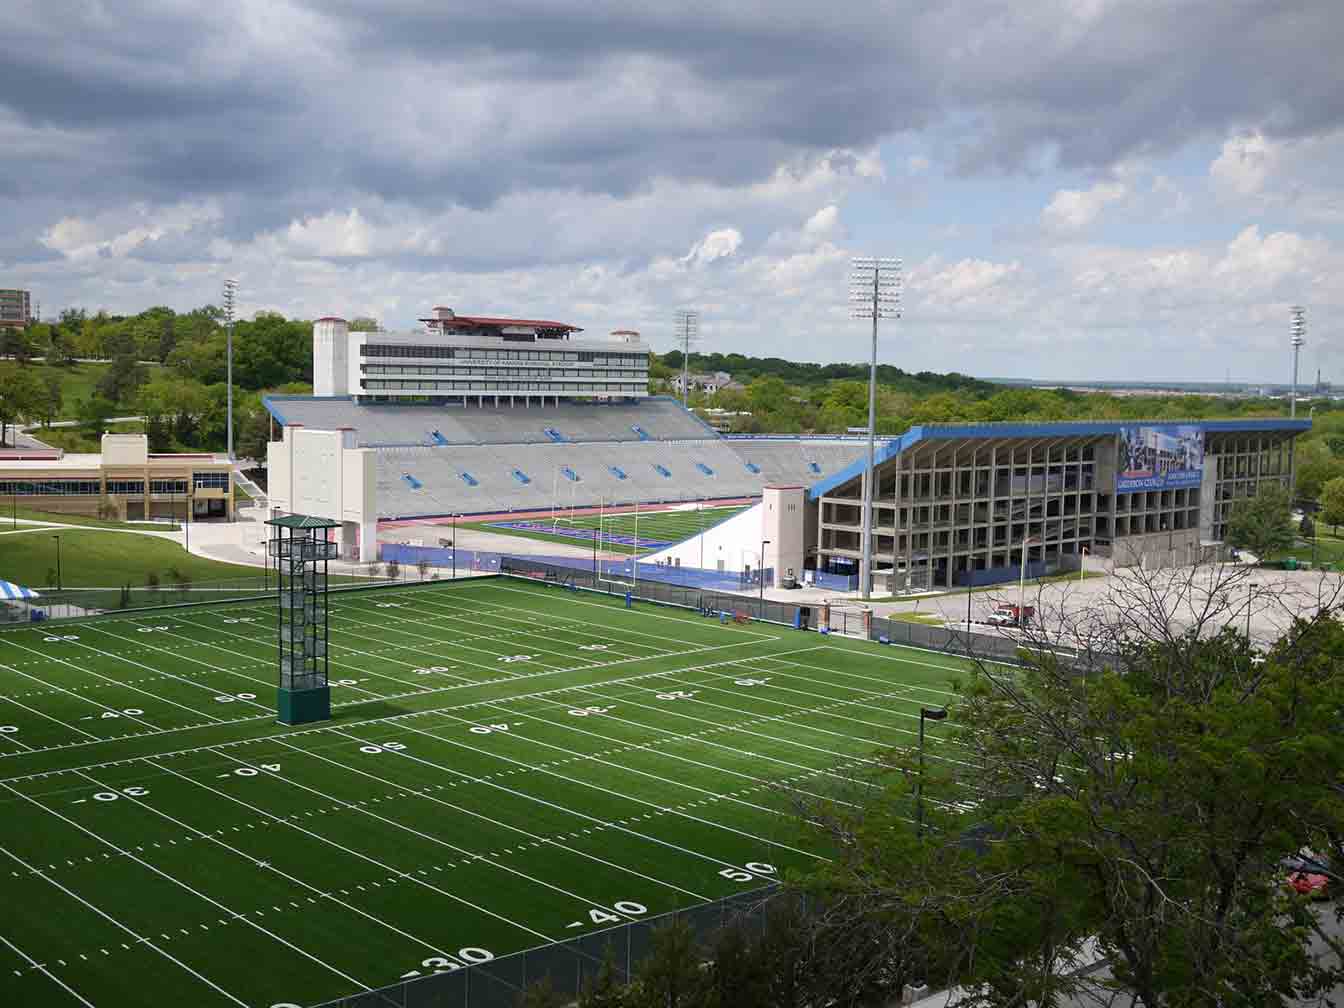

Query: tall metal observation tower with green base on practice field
[266,515,339,724]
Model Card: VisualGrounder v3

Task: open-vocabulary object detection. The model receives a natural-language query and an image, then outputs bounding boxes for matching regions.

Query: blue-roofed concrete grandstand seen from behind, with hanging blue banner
[800,419,1310,591]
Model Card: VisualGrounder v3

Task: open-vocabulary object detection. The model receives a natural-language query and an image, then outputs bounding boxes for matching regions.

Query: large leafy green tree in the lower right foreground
[795,569,1344,1008]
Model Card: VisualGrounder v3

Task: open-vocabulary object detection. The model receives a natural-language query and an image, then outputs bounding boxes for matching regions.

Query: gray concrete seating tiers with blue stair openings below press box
[269,396,866,517]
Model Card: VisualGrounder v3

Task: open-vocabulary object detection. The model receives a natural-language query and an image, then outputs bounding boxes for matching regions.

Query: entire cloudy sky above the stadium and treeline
[0,0,1344,382]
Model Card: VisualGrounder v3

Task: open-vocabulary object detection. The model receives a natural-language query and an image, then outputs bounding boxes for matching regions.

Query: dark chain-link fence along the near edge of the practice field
[316,886,781,1008]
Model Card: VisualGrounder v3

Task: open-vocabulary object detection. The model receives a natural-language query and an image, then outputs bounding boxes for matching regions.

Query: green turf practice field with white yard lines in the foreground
[0,578,960,1008]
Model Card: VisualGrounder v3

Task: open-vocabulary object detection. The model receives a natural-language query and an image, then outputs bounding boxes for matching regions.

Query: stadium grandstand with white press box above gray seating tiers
[265,308,864,555]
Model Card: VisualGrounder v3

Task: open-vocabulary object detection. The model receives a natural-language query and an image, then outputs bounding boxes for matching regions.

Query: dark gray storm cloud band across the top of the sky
[0,0,1344,227]
